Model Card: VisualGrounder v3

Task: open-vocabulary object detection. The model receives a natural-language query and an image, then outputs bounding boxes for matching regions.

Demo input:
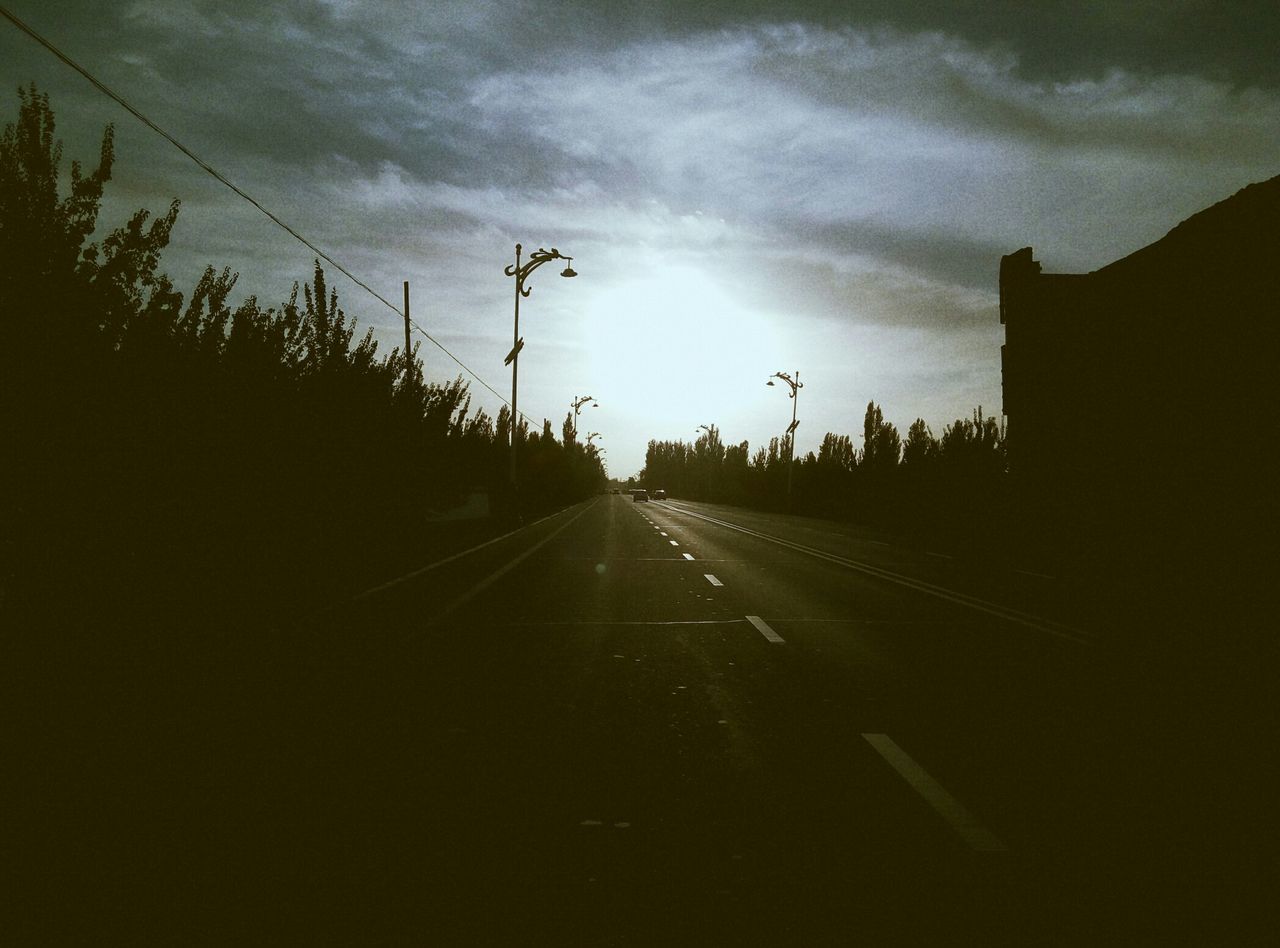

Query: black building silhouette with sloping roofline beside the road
[1000,177,1280,575]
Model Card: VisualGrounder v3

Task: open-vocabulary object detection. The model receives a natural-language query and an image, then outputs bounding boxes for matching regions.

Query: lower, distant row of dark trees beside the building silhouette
[639,402,1010,550]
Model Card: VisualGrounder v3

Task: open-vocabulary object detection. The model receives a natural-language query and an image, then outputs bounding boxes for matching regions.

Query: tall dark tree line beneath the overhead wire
[0,86,605,621]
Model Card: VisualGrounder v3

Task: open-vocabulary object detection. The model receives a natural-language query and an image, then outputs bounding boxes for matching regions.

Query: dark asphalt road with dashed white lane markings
[80,495,1259,944]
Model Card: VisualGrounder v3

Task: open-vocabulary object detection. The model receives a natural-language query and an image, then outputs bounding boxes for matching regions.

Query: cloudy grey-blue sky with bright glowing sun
[0,0,1280,473]
